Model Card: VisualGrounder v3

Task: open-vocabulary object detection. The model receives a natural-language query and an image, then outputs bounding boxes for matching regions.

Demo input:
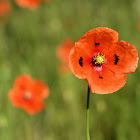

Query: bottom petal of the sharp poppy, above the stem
[86,66,127,94]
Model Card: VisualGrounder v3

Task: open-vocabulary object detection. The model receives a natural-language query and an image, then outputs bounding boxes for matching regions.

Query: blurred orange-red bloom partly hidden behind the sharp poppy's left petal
[56,39,74,73]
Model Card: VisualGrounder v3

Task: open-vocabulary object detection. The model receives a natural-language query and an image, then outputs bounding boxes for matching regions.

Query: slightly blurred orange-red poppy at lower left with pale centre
[9,75,49,114]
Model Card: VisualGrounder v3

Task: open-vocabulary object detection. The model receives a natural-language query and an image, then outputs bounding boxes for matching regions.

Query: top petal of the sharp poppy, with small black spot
[79,27,119,53]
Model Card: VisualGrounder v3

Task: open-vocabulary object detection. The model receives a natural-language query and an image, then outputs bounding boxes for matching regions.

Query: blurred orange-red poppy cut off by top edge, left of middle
[15,0,42,9]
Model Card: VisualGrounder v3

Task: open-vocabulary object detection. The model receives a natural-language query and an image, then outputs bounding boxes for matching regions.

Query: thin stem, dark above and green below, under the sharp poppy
[86,86,90,140]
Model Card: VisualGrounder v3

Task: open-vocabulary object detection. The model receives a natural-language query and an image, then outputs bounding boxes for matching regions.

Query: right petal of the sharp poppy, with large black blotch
[107,41,138,74]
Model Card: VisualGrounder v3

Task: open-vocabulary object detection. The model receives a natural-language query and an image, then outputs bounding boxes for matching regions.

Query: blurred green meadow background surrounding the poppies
[0,0,140,140]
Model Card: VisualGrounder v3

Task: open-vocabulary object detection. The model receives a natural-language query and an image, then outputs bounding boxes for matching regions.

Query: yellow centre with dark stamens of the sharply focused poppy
[92,53,105,66]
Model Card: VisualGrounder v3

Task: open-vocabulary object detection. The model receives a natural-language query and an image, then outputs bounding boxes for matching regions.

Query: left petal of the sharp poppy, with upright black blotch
[69,42,92,79]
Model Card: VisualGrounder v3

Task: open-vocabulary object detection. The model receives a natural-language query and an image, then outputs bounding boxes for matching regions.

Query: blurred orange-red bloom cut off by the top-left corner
[0,0,11,17]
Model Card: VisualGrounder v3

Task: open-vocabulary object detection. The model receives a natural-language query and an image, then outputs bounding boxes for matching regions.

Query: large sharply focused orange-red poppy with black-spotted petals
[69,27,138,94]
